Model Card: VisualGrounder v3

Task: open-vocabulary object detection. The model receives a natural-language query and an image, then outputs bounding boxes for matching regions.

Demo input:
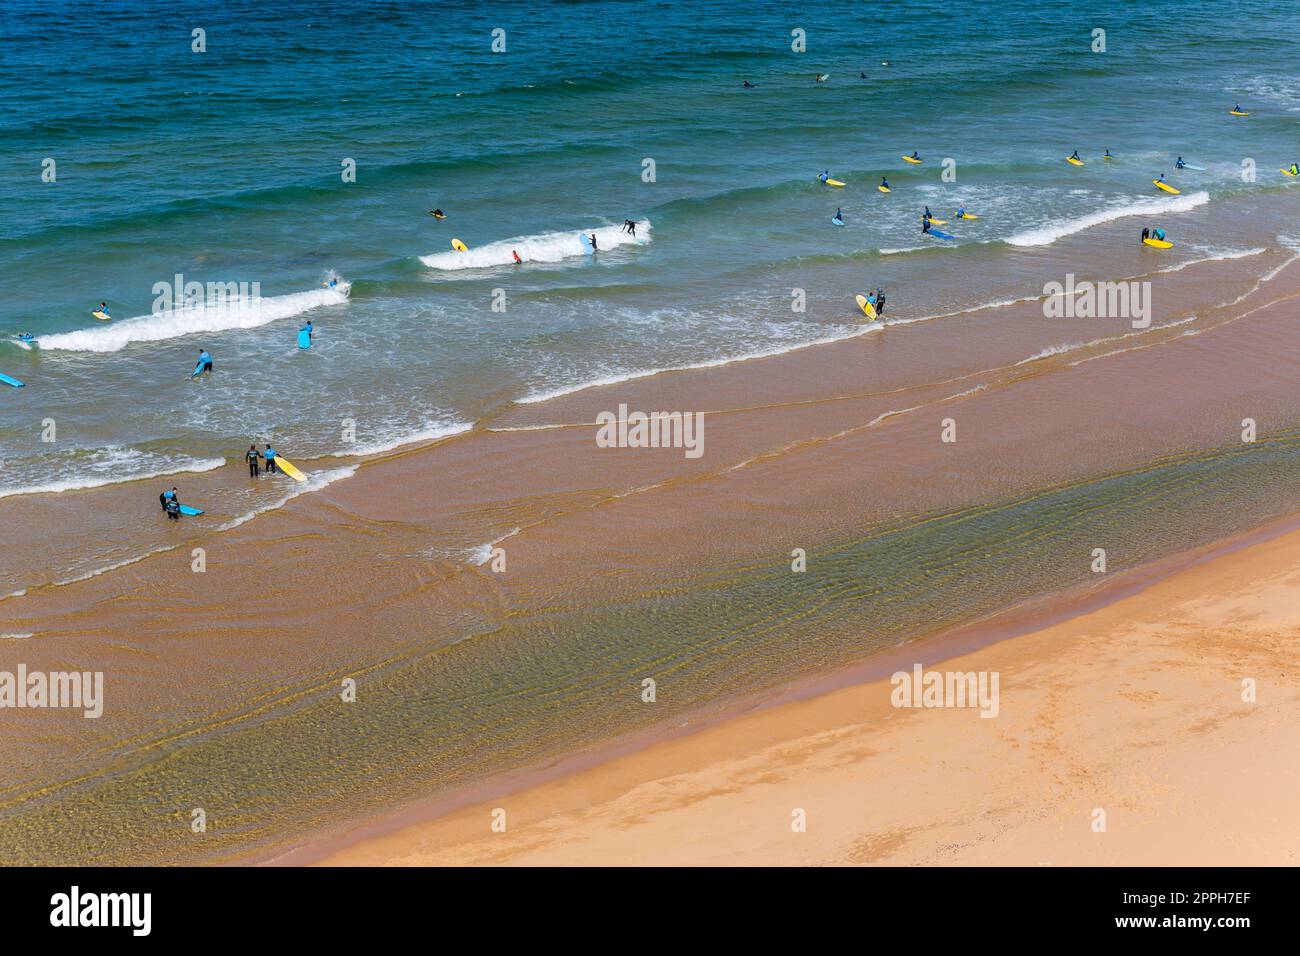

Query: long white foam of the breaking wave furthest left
[36,282,351,352]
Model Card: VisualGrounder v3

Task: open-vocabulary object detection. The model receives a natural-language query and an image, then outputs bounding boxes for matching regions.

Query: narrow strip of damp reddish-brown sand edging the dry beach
[276,511,1300,866]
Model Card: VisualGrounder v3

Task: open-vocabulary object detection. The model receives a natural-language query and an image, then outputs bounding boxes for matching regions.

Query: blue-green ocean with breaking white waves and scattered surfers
[0,0,1300,497]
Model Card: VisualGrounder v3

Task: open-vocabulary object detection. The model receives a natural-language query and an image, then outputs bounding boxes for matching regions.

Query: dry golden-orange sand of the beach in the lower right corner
[314,522,1300,866]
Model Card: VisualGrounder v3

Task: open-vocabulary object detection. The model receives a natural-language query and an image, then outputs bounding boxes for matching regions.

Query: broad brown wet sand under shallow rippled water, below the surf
[0,240,1300,862]
